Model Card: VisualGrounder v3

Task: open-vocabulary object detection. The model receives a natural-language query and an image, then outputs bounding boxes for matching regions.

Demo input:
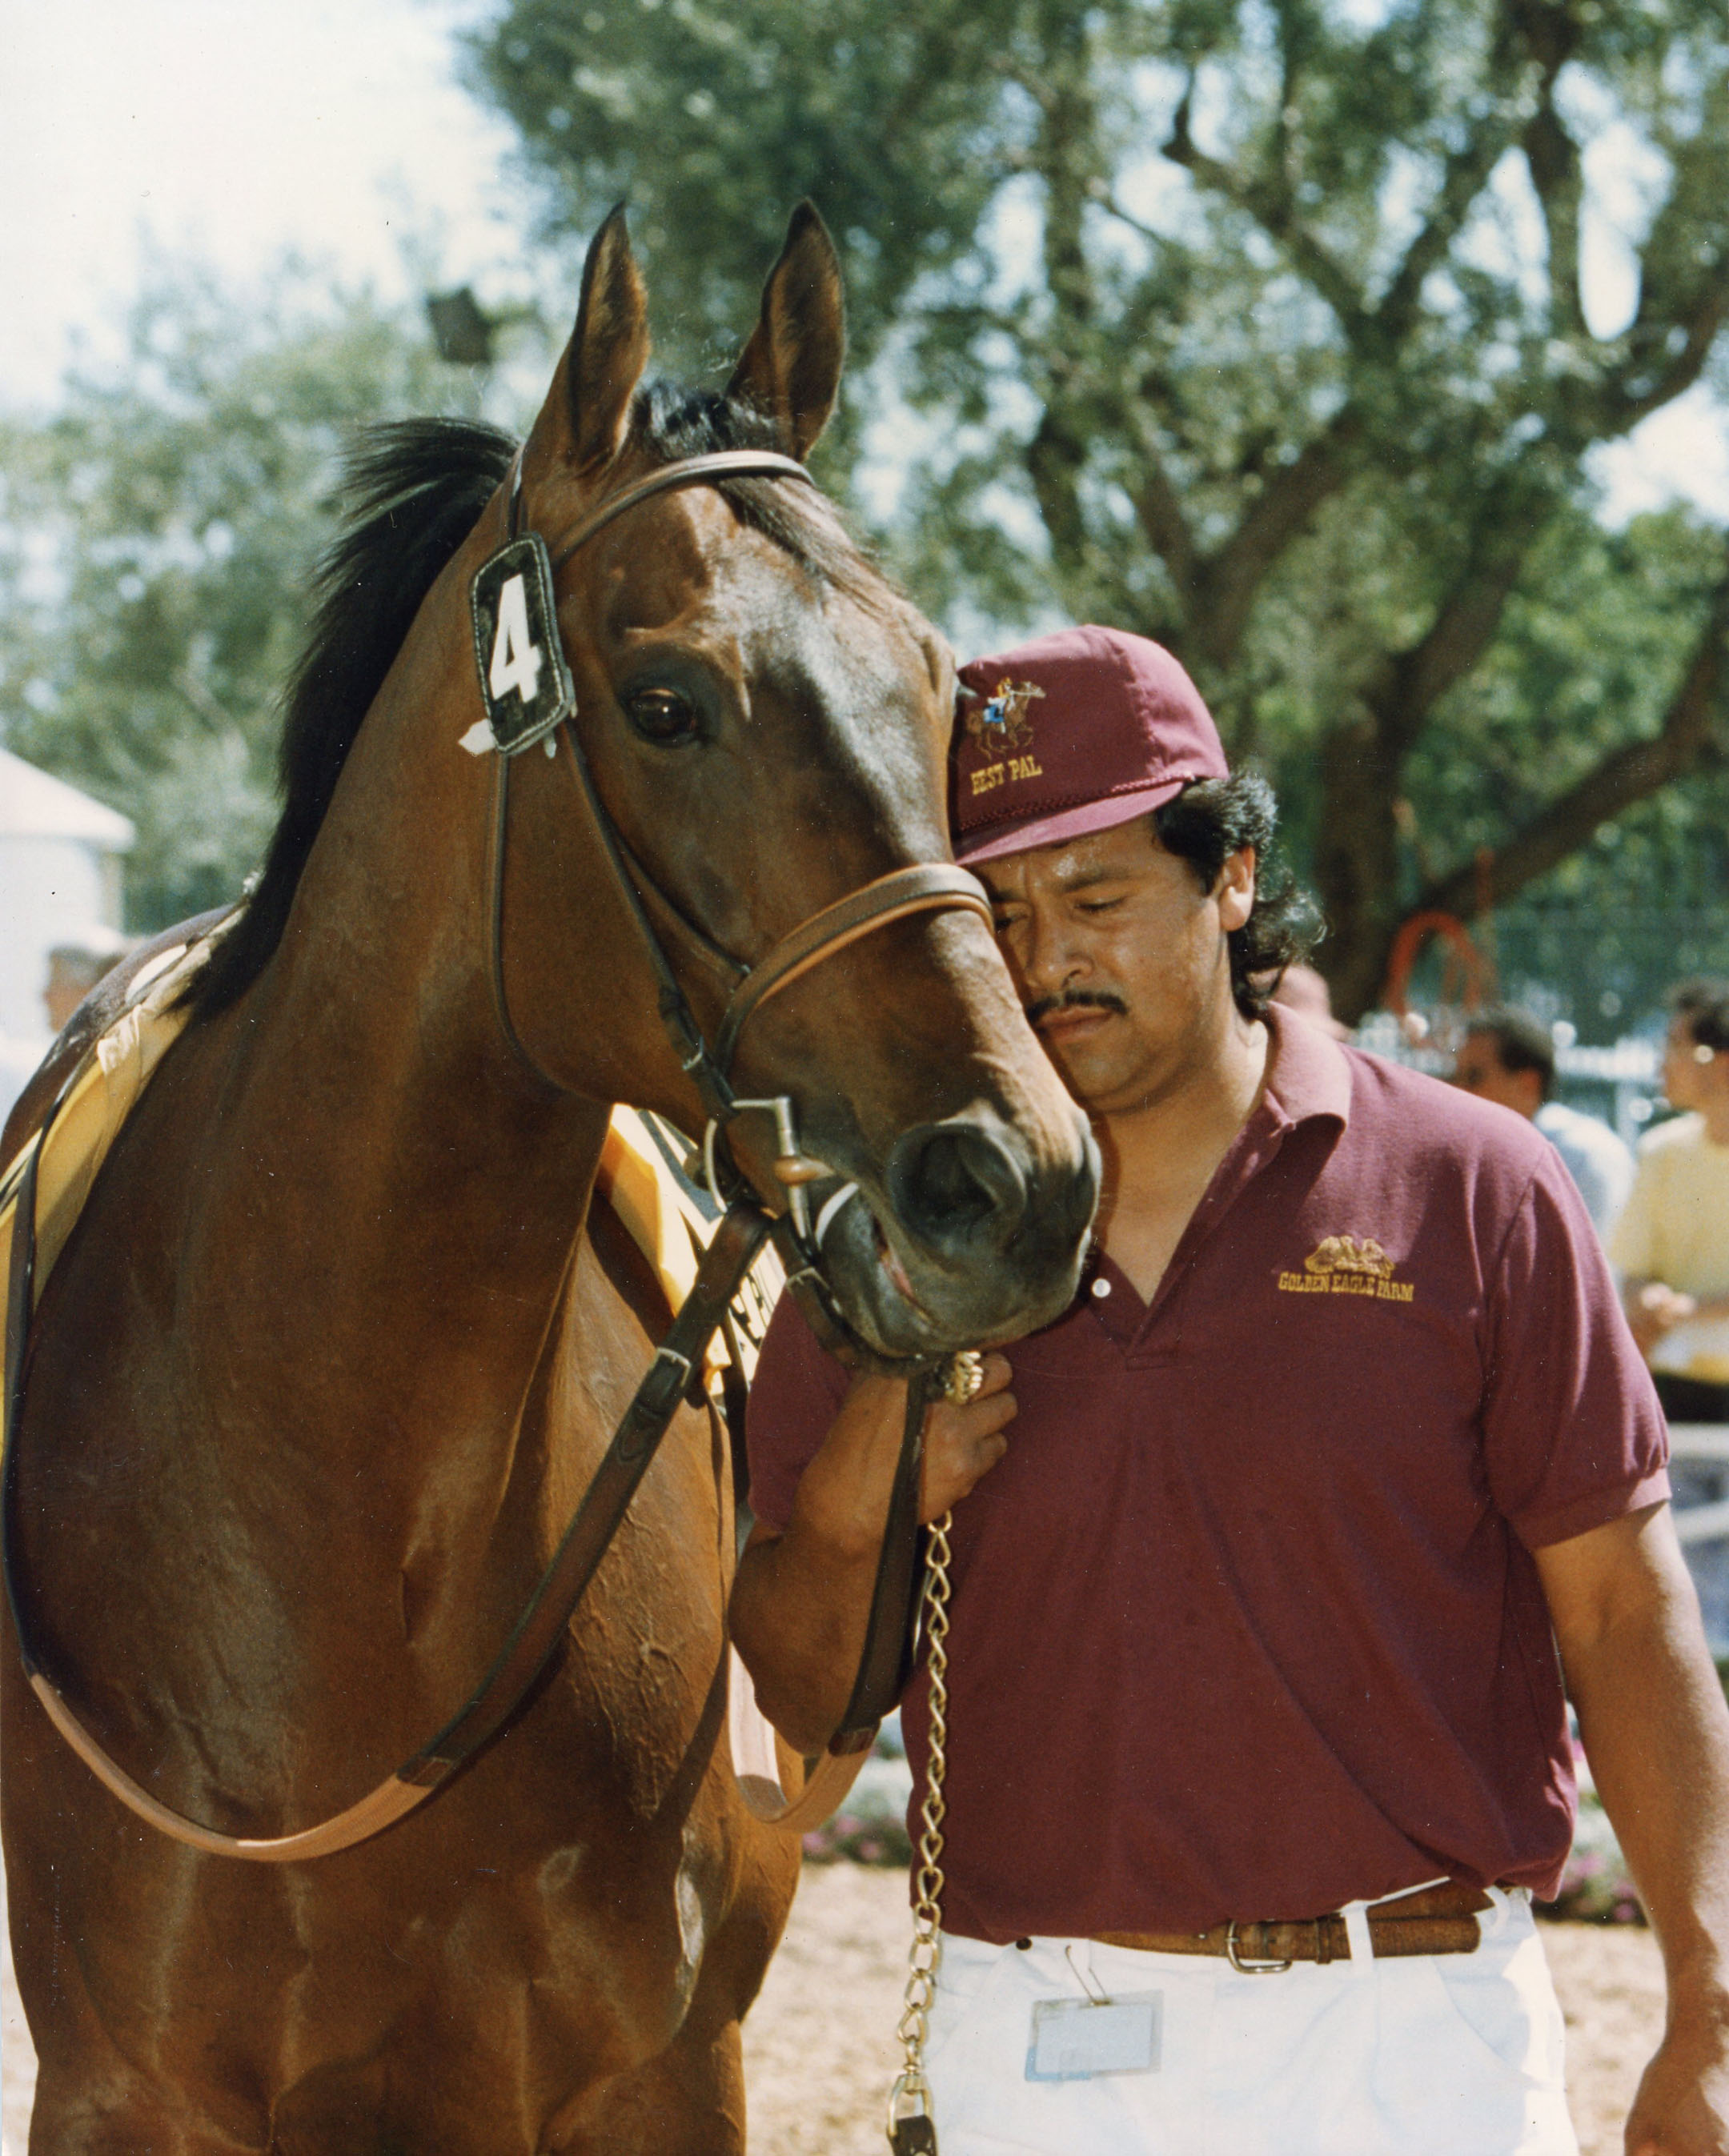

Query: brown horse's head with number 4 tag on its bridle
[471,207,1095,1357]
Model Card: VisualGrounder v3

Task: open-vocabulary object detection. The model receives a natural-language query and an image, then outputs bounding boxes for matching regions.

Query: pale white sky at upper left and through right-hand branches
[0,0,1729,515]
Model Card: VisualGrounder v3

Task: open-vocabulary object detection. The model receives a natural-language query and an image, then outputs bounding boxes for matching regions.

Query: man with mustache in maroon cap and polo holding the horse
[733,627,1729,2156]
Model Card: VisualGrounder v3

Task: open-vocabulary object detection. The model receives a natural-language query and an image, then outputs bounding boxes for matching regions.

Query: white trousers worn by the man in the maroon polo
[925,1893,1578,2156]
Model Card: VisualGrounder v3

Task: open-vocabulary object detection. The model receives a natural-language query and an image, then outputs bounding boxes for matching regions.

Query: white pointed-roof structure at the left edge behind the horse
[0,748,136,1040]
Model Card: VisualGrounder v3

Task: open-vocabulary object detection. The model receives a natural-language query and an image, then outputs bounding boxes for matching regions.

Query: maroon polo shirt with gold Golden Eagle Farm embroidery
[750,1007,1669,1941]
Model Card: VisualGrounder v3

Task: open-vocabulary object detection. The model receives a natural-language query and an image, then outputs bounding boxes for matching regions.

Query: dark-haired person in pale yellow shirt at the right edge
[1608,981,1729,1423]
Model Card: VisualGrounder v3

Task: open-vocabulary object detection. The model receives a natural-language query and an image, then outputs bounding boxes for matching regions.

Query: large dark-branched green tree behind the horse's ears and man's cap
[475,0,1729,1011]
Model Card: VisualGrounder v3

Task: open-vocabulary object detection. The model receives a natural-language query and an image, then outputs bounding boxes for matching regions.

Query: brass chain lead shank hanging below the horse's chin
[889,1354,985,2156]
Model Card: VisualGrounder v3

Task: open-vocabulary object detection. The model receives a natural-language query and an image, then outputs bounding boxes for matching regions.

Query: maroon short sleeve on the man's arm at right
[1483,1160,1669,1550]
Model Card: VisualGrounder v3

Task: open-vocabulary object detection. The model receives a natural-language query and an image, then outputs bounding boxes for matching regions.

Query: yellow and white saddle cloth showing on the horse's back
[0,938,783,1380]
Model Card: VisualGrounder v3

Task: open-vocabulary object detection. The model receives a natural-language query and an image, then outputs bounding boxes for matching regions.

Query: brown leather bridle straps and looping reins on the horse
[0,451,992,1863]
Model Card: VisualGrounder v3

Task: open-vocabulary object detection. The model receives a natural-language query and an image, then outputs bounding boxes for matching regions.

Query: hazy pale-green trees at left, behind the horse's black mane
[0,270,461,929]
